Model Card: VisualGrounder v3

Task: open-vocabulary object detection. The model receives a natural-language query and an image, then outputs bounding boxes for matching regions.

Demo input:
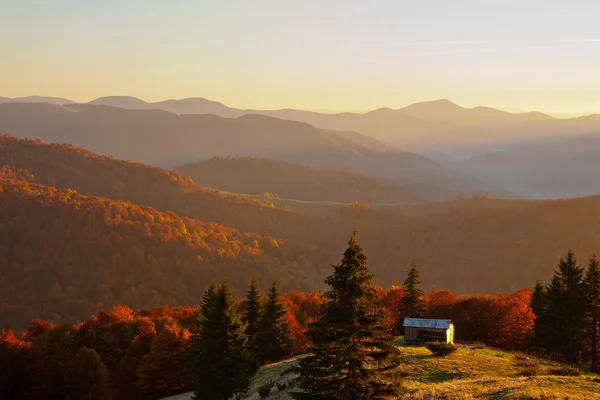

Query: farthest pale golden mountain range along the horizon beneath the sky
[0,96,600,151]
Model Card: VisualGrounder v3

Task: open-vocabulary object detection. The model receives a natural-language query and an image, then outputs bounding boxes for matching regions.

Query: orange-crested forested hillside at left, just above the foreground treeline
[0,174,327,329]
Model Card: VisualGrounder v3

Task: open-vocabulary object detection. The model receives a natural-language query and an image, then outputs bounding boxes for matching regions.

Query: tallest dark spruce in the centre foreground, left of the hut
[292,231,400,400]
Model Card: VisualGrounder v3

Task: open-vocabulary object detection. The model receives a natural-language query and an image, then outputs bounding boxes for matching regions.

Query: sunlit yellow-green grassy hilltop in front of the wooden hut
[162,340,600,400]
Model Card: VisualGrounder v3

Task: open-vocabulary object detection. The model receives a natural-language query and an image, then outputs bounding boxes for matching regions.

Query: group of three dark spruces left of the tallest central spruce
[189,279,294,400]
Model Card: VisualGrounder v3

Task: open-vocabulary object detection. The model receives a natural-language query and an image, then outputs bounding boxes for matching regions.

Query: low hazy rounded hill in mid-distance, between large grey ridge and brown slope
[176,157,423,204]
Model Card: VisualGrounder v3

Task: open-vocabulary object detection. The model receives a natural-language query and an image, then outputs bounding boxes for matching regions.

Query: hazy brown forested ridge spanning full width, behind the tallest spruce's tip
[5,138,600,304]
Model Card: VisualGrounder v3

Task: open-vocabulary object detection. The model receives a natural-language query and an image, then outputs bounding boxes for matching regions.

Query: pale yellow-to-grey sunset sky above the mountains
[0,0,600,114]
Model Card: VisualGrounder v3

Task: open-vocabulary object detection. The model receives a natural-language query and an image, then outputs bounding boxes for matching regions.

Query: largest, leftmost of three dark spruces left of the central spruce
[190,282,258,400]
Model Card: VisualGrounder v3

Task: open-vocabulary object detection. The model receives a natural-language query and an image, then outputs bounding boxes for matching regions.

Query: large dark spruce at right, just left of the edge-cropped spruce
[543,250,585,364]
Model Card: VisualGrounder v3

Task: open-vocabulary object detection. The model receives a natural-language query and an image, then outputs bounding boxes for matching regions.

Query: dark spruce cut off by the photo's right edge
[584,255,600,372]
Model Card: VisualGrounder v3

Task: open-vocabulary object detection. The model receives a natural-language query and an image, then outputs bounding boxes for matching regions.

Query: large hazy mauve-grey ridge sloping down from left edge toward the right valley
[0,103,513,198]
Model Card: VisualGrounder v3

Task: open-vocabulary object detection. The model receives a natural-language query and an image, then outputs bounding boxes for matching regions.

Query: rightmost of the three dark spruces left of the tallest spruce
[254,283,294,364]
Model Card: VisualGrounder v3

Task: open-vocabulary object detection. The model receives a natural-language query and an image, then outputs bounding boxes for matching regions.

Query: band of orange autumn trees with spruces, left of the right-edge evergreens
[0,234,534,399]
